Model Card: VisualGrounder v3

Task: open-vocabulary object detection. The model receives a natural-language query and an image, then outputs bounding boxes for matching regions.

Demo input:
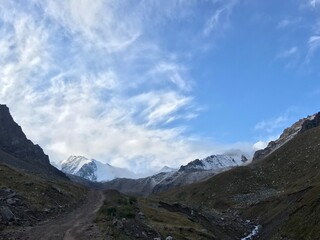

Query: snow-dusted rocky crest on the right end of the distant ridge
[179,152,249,171]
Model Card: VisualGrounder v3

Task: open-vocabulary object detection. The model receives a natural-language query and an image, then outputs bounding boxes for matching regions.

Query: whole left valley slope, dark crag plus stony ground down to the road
[0,105,87,232]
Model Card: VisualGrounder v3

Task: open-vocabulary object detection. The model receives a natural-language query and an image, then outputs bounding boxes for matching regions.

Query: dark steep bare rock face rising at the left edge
[0,104,67,178]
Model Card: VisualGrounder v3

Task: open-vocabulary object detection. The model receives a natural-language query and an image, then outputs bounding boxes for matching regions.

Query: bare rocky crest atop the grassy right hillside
[253,112,320,161]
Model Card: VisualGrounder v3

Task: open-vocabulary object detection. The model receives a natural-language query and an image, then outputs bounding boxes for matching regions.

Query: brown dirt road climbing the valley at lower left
[9,191,104,240]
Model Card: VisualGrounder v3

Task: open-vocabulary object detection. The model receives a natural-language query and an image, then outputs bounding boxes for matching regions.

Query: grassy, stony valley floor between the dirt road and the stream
[96,190,254,240]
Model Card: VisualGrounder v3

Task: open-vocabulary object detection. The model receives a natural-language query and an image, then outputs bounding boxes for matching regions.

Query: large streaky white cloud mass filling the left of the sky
[0,0,241,171]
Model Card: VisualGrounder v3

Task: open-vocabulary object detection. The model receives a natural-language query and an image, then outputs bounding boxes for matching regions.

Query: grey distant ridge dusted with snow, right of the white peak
[103,151,249,196]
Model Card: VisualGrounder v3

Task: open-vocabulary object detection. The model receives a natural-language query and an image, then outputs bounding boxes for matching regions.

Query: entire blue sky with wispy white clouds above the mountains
[0,0,320,172]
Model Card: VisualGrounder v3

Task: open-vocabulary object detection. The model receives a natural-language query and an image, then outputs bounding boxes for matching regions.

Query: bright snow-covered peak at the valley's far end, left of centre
[61,156,135,182]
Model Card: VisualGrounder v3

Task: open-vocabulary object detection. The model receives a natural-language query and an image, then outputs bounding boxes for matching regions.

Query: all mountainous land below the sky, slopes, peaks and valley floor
[0,105,320,240]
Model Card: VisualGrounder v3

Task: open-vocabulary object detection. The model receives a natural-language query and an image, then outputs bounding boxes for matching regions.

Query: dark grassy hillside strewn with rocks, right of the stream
[154,127,320,239]
